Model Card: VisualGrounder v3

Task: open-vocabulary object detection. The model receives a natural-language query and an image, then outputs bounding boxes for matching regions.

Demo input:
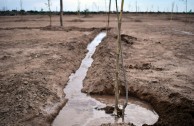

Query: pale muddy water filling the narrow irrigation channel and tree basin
[52,32,159,126]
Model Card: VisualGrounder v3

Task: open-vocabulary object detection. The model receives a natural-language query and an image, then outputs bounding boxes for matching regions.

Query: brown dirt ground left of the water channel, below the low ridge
[0,28,104,126]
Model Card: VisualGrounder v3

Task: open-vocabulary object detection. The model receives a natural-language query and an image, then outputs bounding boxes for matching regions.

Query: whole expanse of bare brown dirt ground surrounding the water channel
[0,15,194,126]
